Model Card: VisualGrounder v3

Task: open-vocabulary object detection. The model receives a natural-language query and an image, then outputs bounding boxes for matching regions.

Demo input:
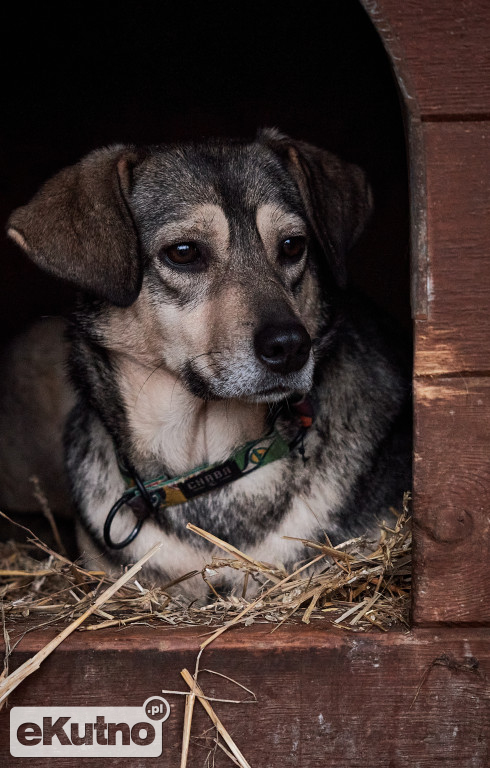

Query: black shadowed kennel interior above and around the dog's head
[0,0,411,552]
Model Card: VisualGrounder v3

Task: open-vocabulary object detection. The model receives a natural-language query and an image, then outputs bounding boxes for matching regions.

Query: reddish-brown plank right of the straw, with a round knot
[413,376,490,624]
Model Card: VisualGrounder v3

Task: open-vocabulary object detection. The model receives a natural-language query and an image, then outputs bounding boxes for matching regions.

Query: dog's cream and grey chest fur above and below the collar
[72,336,408,579]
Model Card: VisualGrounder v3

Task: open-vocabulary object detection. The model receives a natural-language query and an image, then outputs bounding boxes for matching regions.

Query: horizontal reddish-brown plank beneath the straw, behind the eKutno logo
[0,624,490,768]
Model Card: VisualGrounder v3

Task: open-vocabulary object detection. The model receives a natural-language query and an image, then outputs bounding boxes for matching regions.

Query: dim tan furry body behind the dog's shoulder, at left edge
[0,317,75,530]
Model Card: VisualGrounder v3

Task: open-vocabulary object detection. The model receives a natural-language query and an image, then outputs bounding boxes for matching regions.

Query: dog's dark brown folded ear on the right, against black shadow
[258,129,372,288]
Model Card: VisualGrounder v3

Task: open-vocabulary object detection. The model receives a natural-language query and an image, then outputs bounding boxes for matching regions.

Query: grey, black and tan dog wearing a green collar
[4,129,411,588]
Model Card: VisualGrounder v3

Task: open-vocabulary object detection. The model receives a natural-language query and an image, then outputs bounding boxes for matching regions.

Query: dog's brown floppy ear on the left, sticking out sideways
[7,145,142,306]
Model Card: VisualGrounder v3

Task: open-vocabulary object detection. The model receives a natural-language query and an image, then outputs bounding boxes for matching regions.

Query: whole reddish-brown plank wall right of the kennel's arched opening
[363,0,490,625]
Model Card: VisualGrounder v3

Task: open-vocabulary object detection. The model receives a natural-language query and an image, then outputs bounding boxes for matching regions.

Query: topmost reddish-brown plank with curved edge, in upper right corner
[362,0,490,119]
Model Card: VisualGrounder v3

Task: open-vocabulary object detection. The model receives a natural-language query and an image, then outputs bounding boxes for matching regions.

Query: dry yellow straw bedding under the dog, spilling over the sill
[0,494,411,768]
